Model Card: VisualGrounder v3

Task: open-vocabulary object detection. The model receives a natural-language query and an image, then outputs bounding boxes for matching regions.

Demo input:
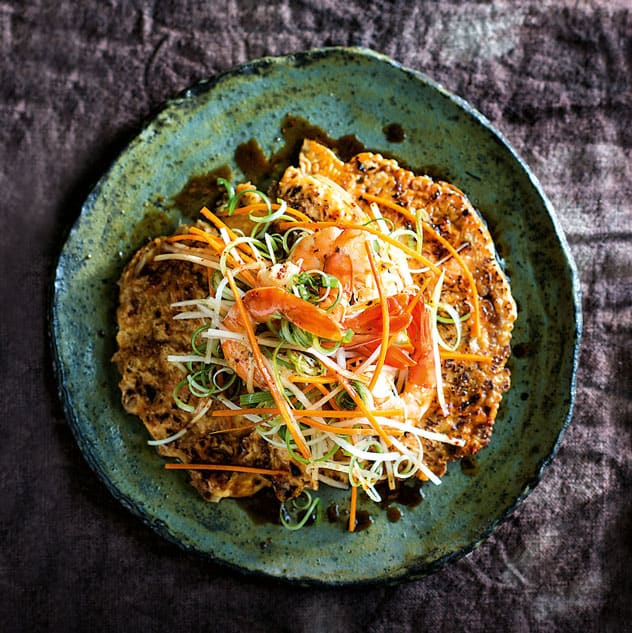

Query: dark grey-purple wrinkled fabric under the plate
[0,0,632,633]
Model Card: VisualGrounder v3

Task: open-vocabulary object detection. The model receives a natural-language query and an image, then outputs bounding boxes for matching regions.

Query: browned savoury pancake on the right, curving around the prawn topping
[279,140,516,476]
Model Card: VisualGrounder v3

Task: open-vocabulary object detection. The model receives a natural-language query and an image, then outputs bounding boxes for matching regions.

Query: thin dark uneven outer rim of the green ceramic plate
[47,46,583,587]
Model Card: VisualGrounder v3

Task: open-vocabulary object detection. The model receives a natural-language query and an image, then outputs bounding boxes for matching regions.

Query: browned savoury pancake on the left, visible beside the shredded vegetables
[113,235,312,501]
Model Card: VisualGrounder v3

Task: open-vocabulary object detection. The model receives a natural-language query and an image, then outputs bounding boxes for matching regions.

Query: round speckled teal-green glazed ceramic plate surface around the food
[51,48,581,585]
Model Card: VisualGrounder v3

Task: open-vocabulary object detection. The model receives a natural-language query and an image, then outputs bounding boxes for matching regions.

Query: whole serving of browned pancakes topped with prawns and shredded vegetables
[113,140,516,508]
